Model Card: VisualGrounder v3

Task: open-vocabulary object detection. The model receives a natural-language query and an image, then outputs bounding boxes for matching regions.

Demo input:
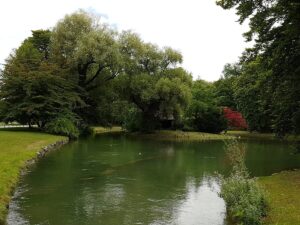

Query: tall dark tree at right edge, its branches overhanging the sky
[217,0,300,135]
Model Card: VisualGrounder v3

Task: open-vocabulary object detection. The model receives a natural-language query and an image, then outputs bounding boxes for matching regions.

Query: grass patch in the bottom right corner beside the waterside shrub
[258,170,300,225]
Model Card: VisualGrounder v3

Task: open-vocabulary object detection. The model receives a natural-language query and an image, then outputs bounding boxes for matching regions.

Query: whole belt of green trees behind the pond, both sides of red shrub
[0,0,300,137]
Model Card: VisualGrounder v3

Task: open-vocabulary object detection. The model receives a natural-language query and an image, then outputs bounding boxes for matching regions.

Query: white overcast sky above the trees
[0,0,247,81]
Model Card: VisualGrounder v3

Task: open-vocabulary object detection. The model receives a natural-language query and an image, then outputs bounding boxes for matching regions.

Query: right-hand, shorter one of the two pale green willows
[120,32,192,130]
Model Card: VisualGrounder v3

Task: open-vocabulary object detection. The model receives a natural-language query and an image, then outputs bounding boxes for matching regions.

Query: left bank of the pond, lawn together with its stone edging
[0,130,70,225]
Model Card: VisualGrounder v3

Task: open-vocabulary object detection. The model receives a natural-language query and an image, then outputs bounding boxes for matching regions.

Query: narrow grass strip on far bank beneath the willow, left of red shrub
[129,130,232,141]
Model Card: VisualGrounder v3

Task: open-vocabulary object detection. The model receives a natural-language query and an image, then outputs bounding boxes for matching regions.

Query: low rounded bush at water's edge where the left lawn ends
[45,115,79,139]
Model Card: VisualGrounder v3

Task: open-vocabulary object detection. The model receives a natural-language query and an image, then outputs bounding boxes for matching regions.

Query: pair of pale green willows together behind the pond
[51,11,191,129]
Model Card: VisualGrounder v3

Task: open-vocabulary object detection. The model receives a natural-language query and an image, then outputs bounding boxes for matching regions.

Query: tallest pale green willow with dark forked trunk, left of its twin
[51,11,122,123]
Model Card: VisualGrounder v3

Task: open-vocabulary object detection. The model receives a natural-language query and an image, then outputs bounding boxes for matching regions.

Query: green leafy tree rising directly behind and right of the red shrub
[234,58,275,132]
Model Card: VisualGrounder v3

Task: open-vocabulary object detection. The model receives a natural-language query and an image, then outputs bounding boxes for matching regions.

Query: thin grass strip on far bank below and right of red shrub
[226,130,300,141]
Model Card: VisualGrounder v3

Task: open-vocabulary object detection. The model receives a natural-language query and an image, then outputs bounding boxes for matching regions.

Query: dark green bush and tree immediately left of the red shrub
[185,80,227,133]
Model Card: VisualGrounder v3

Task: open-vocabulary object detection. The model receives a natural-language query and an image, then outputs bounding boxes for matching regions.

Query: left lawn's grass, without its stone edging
[0,129,66,224]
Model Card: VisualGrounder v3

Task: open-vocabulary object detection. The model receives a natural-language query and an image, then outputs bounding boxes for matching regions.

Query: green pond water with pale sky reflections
[7,135,300,225]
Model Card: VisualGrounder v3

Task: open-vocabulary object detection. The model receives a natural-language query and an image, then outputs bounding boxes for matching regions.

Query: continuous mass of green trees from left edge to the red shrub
[0,11,226,137]
